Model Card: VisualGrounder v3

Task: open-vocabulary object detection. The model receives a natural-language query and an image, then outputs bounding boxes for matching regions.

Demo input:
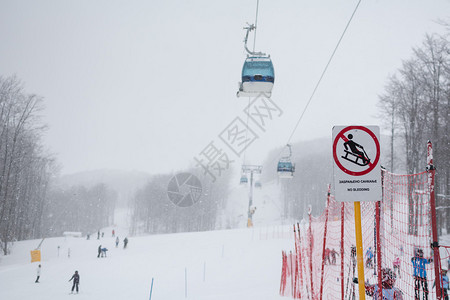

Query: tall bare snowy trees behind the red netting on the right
[379,34,450,233]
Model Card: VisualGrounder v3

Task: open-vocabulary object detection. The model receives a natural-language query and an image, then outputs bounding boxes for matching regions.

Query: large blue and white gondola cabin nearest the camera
[237,56,275,97]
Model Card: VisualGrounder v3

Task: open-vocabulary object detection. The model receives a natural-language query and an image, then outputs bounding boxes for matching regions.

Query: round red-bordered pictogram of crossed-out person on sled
[333,126,380,176]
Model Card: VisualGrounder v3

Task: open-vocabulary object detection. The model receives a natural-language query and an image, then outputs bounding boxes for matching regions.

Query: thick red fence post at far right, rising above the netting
[427,141,442,300]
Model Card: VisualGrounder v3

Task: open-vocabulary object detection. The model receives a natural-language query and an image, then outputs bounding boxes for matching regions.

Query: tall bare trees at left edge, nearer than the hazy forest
[0,76,53,255]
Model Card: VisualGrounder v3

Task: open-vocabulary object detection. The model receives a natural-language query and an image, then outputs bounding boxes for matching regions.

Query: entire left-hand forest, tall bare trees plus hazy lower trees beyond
[0,76,115,255]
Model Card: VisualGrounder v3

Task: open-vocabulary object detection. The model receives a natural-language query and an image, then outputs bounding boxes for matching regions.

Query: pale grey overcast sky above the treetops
[0,0,450,173]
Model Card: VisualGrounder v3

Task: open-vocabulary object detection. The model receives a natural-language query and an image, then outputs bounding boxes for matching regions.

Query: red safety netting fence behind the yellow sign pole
[280,164,444,299]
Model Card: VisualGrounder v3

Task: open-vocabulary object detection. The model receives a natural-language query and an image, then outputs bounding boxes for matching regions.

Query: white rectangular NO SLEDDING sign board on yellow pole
[333,126,382,202]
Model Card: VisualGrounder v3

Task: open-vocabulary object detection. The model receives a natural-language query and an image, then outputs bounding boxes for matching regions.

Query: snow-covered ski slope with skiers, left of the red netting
[0,227,292,300]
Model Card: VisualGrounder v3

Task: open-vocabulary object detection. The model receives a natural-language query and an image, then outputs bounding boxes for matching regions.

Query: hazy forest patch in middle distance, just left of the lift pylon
[130,168,232,235]
